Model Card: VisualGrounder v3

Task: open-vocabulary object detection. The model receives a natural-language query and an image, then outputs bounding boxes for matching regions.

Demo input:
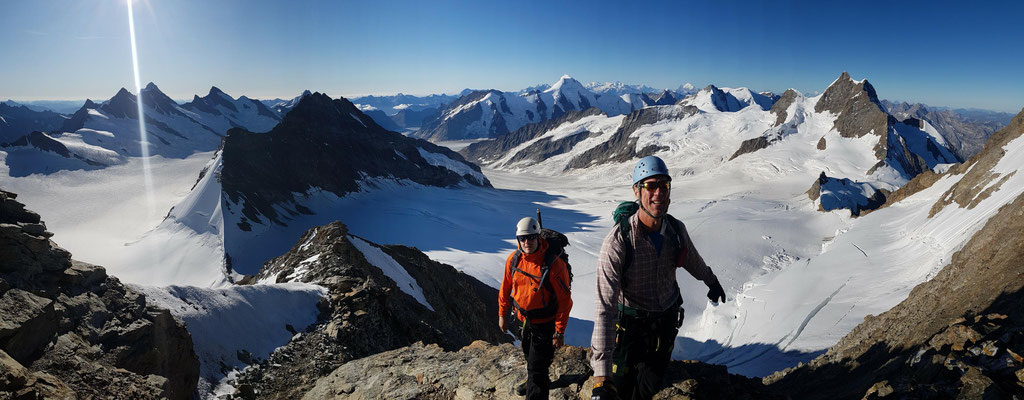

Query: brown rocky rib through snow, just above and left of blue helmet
[565,105,700,170]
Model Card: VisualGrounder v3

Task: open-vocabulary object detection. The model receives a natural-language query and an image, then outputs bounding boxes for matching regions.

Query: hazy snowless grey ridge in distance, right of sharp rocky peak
[882,100,1012,160]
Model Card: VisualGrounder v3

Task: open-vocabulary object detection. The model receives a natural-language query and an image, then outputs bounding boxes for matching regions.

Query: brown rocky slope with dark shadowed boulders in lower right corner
[765,184,1024,399]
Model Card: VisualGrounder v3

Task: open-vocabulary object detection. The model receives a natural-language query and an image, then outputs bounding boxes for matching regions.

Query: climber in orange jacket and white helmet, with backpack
[498,217,572,399]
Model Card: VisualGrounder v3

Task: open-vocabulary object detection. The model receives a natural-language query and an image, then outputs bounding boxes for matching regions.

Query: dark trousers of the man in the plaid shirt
[612,315,679,400]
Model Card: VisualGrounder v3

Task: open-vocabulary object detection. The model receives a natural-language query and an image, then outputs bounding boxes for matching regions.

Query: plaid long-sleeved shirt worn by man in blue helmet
[591,213,717,376]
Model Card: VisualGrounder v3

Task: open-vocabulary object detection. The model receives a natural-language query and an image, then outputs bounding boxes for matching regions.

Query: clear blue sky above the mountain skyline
[0,0,1024,113]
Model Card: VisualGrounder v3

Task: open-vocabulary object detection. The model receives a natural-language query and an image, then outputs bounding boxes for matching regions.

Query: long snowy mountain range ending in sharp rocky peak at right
[462,73,962,214]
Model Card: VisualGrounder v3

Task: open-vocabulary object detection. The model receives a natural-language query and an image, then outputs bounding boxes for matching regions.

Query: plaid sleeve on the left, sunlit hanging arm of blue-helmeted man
[590,226,623,376]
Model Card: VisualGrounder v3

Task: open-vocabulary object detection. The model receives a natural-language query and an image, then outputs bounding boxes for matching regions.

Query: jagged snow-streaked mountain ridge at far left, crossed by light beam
[2,83,280,176]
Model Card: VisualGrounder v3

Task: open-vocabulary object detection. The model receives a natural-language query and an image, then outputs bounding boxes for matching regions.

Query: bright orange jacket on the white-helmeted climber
[498,238,572,334]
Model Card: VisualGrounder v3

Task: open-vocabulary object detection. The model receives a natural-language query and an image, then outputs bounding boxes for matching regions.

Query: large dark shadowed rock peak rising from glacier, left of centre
[220,93,490,229]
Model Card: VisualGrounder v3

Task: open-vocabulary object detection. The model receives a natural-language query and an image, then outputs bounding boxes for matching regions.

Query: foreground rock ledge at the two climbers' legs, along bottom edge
[303,342,782,400]
